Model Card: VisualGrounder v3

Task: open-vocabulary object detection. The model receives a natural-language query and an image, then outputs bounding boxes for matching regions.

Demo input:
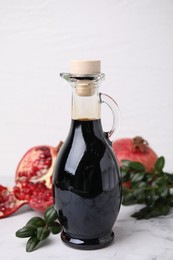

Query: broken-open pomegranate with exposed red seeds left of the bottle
[0,142,62,218]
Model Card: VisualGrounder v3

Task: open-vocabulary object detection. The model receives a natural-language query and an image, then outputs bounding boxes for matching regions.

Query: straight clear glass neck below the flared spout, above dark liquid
[72,84,101,120]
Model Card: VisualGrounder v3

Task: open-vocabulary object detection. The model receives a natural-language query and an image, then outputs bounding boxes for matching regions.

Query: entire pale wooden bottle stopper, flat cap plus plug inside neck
[70,60,100,96]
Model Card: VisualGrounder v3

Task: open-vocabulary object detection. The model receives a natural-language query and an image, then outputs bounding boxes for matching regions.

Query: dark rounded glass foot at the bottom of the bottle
[61,231,114,250]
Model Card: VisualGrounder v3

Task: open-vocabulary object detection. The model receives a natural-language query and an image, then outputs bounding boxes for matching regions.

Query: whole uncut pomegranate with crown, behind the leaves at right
[112,136,158,172]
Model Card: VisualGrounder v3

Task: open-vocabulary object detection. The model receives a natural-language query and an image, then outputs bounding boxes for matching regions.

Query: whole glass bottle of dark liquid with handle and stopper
[53,61,121,249]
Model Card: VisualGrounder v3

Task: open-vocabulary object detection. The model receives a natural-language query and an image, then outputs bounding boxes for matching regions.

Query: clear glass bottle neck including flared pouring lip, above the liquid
[60,73,104,120]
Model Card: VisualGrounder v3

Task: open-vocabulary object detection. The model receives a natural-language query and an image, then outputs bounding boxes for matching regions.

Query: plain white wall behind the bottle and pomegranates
[0,0,173,179]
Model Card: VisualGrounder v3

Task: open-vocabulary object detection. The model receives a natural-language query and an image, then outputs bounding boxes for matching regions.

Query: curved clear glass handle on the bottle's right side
[99,93,120,142]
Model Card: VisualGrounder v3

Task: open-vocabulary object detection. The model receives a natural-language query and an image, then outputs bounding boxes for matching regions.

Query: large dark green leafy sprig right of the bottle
[121,156,173,219]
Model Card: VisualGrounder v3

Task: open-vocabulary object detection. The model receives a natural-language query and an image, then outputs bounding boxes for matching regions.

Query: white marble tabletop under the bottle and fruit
[0,178,173,260]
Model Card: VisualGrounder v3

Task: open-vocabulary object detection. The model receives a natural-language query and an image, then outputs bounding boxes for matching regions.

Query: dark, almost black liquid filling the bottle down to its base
[53,120,121,249]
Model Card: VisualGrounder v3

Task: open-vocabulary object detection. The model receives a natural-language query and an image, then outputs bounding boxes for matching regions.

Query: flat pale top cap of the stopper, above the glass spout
[70,60,101,75]
